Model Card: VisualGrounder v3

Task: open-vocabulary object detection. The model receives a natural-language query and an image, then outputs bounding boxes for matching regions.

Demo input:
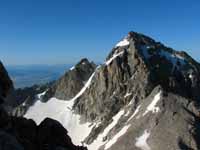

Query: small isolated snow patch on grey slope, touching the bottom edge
[135,130,151,150]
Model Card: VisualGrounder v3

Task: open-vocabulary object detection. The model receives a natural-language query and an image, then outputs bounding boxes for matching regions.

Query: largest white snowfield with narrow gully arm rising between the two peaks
[25,73,95,145]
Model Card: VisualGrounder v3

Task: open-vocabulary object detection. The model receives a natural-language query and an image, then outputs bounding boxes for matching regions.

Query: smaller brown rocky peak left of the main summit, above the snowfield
[43,58,96,101]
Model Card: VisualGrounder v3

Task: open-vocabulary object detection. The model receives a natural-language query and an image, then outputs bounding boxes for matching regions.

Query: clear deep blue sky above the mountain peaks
[0,0,200,65]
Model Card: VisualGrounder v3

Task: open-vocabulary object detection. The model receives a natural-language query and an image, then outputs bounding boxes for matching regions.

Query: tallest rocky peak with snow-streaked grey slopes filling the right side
[70,32,200,150]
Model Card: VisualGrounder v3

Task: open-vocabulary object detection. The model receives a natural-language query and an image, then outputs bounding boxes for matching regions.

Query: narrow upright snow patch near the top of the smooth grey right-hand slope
[143,91,162,116]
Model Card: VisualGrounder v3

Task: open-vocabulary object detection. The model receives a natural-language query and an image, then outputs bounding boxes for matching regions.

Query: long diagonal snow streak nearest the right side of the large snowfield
[88,110,124,150]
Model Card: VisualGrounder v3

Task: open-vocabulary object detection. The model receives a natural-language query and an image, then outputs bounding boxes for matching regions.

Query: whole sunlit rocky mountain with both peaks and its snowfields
[2,32,200,150]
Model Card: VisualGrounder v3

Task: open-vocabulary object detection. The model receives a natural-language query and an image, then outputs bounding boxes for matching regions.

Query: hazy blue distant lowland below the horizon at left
[6,65,72,88]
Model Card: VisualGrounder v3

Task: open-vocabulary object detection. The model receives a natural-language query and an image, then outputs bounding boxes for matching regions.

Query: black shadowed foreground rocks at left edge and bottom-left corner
[0,61,87,150]
